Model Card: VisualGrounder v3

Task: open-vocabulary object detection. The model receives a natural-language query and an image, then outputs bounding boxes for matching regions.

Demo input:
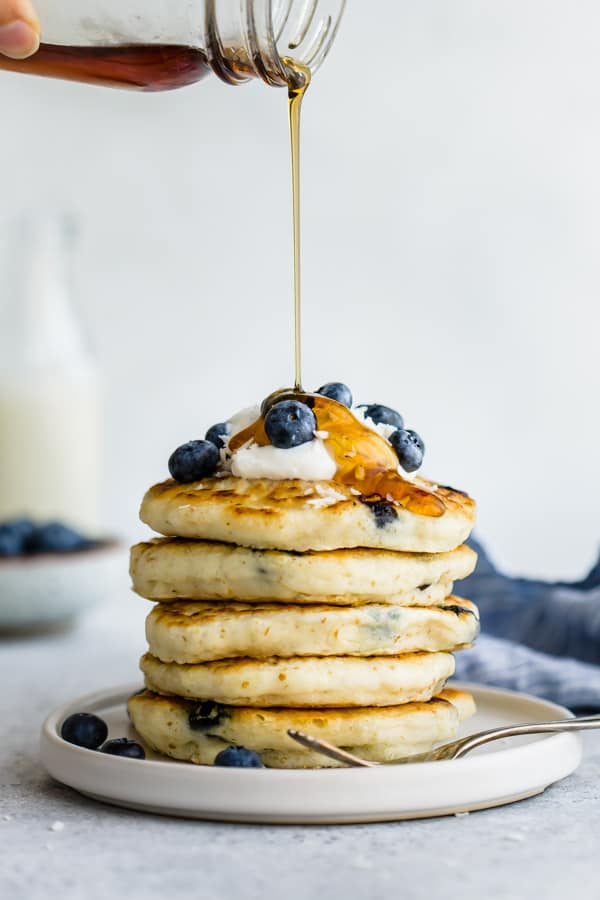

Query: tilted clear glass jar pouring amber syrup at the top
[0,0,345,91]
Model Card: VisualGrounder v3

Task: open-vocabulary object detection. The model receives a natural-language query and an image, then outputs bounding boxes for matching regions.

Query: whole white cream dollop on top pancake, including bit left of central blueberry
[221,406,337,481]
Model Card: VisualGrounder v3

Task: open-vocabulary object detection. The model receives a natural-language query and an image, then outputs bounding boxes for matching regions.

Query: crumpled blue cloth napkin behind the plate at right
[456,539,600,710]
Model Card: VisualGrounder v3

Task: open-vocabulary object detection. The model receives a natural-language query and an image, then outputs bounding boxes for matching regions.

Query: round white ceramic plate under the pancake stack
[41,685,581,824]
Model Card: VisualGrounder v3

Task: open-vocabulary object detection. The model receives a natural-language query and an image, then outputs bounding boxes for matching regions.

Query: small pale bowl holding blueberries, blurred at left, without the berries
[0,541,126,631]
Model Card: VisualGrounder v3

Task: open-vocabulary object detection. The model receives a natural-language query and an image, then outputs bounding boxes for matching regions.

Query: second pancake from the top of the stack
[130,538,477,606]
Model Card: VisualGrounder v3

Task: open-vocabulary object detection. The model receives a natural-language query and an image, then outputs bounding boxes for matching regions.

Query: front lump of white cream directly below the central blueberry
[231,438,337,481]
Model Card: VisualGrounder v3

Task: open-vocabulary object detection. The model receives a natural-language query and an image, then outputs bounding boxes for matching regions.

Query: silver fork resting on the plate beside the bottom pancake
[288,715,600,768]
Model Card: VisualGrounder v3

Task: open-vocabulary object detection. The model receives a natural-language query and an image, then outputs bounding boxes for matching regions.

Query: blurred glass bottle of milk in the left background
[0,219,100,534]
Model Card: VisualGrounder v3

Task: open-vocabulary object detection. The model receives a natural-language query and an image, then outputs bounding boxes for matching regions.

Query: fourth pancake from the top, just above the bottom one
[140,653,454,708]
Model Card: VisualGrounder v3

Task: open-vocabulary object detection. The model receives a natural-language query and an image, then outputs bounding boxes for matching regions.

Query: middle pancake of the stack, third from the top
[146,597,479,663]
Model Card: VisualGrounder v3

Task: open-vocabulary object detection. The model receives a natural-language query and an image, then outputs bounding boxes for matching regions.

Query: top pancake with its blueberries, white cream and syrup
[141,388,475,553]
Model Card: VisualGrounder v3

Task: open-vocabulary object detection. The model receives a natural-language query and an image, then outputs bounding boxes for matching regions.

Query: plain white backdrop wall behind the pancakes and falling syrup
[0,0,600,577]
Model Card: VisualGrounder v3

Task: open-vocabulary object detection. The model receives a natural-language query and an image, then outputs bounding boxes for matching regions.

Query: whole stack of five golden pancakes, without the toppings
[129,475,479,768]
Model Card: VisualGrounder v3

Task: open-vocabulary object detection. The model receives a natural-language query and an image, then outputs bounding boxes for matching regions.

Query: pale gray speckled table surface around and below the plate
[0,590,600,900]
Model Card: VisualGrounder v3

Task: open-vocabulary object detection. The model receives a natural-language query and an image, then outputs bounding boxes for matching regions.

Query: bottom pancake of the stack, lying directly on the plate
[128,689,475,768]
